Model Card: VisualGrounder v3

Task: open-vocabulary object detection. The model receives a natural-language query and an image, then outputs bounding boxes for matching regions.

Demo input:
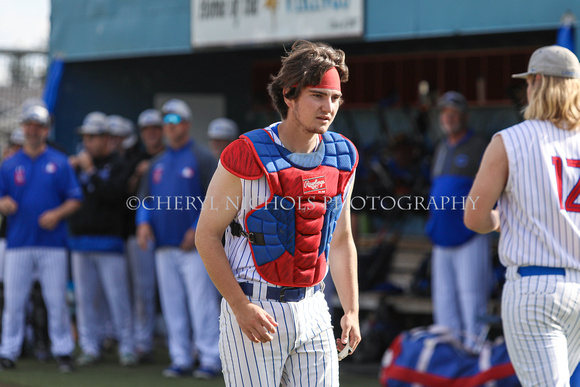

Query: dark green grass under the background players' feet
[0,349,379,387]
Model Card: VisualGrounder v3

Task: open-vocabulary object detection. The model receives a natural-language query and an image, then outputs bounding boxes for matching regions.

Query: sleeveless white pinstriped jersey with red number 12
[498,120,580,269]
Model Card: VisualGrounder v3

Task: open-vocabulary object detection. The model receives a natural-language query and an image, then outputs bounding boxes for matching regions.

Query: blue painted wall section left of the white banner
[50,0,191,61]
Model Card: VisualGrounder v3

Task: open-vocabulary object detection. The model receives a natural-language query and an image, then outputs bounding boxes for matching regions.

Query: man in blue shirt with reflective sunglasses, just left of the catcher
[137,99,221,378]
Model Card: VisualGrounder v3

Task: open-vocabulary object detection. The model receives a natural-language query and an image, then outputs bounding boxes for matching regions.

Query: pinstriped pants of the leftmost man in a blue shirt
[0,247,74,360]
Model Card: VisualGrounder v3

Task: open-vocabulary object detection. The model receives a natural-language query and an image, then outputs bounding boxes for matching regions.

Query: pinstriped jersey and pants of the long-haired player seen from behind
[499,120,580,386]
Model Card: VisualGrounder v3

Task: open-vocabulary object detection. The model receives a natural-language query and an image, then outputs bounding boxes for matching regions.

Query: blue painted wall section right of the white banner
[365,0,580,52]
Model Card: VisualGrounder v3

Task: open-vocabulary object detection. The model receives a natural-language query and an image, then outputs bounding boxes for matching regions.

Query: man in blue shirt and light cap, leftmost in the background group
[0,105,82,372]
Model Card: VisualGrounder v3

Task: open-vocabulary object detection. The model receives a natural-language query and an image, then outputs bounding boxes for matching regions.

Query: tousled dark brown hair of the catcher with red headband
[268,40,348,119]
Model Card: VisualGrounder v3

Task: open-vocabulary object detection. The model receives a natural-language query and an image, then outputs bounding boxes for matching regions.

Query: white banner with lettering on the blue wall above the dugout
[191,0,364,47]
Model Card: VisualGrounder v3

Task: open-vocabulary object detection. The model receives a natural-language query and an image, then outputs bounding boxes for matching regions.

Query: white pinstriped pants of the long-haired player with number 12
[501,267,580,387]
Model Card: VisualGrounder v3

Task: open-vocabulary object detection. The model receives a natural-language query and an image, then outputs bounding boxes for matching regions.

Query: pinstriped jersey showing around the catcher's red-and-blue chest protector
[224,123,354,284]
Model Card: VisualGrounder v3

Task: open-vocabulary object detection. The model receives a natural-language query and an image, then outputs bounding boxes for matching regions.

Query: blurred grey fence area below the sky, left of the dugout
[0,49,48,153]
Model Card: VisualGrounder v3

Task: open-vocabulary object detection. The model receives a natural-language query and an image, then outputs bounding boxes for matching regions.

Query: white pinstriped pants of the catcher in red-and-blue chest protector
[220,286,339,387]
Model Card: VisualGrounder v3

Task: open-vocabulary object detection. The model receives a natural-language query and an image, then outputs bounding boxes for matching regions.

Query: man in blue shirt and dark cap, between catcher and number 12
[427,91,491,347]
